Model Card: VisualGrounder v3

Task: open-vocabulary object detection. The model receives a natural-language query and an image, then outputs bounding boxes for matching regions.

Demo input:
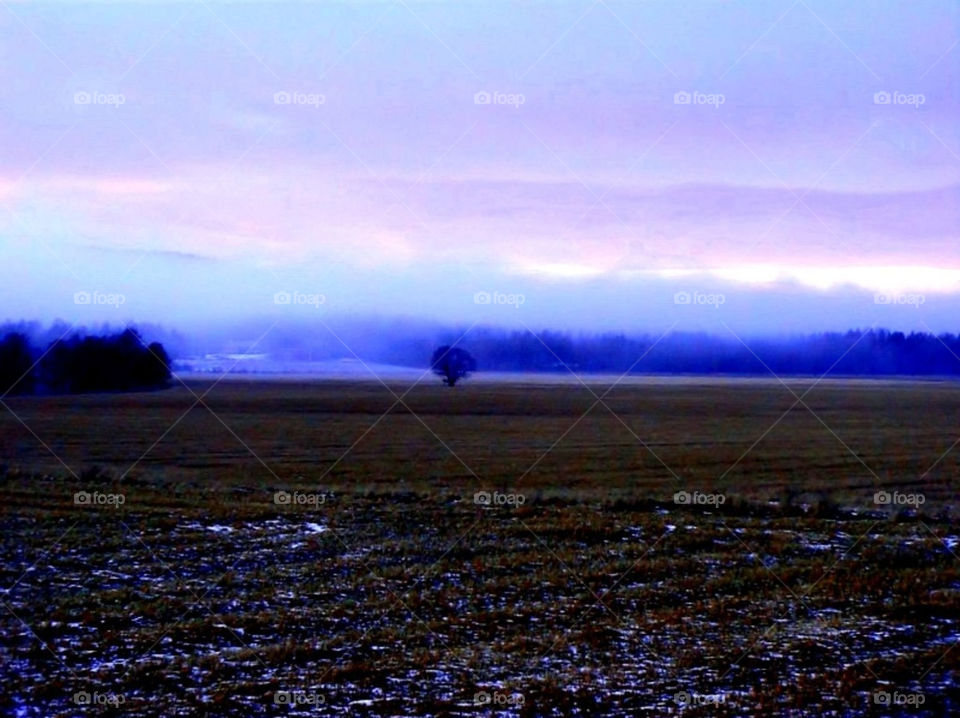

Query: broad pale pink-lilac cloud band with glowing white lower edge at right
[0,166,960,286]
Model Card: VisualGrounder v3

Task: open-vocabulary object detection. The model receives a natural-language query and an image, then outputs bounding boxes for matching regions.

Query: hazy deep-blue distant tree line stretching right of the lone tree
[420,329,960,376]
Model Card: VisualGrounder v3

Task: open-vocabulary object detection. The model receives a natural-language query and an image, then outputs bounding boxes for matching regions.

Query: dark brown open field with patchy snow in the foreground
[0,377,960,716]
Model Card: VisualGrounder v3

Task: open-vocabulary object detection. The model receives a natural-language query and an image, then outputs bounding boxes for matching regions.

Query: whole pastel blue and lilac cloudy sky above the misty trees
[0,0,960,333]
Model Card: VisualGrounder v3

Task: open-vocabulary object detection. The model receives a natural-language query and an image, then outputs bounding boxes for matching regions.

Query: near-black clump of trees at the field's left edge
[0,329,171,396]
